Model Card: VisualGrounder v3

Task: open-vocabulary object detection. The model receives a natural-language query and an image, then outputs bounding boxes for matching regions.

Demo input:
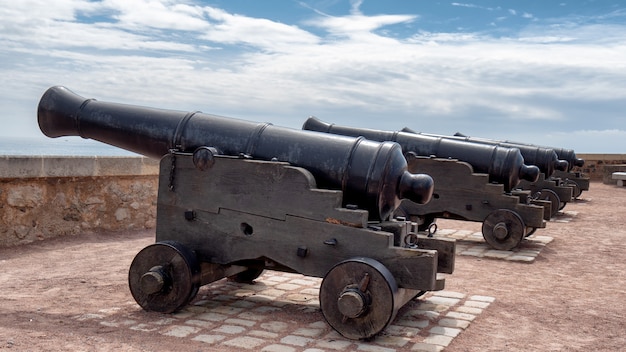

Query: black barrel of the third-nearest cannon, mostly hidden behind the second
[402,131,569,179]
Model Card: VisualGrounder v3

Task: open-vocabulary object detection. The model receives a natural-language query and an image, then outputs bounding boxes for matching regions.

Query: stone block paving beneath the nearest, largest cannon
[74,270,495,352]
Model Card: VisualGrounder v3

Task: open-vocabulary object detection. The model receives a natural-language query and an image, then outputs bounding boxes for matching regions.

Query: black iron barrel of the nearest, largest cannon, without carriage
[37,86,433,220]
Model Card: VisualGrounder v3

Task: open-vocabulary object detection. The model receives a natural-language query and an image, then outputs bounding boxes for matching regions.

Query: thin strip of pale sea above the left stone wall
[0,136,139,156]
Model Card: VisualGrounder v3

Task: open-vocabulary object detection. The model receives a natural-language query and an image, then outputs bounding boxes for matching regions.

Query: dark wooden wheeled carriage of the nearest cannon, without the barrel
[129,148,455,339]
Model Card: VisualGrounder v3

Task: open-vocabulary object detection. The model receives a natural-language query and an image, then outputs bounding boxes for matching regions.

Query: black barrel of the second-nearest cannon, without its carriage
[302,117,539,191]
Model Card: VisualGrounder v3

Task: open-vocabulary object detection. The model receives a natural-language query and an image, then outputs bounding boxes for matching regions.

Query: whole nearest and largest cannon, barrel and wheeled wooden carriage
[37,86,455,339]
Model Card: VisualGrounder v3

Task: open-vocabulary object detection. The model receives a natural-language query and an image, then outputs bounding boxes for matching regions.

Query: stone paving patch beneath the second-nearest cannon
[424,211,578,263]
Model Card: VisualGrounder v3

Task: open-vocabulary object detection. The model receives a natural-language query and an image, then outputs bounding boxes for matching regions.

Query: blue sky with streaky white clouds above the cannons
[0,0,626,153]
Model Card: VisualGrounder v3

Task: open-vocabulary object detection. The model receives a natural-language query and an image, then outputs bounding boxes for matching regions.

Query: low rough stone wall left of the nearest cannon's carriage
[0,156,158,246]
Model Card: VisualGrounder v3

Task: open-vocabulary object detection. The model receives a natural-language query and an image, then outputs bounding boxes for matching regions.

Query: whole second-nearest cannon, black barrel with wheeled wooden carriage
[303,117,549,250]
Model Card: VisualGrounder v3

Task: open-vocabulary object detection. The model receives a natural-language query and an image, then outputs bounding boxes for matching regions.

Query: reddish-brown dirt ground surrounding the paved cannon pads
[0,183,626,352]
